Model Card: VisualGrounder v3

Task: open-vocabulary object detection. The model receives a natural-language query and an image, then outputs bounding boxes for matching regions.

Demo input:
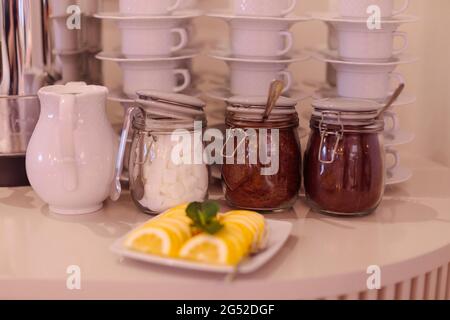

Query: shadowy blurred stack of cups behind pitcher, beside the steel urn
[49,0,102,84]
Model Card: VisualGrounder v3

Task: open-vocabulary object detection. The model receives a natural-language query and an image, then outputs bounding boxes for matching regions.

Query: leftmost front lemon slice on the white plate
[125,227,181,257]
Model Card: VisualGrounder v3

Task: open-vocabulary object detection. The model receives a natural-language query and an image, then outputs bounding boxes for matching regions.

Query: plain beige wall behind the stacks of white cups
[100,0,450,166]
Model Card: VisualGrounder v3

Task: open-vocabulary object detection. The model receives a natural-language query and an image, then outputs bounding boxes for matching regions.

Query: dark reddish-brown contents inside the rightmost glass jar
[304,121,385,215]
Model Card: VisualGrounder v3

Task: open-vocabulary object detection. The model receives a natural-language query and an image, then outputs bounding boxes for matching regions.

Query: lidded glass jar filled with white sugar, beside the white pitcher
[114,92,209,214]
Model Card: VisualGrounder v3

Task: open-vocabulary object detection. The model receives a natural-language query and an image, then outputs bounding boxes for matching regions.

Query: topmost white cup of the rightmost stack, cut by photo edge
[339,0,409,18]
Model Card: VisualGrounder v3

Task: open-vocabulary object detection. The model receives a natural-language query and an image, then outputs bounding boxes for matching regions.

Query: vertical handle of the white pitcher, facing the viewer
[58,94,78,192]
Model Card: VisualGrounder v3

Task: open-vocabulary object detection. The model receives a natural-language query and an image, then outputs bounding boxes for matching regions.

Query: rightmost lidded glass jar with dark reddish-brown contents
[304,98,385,216]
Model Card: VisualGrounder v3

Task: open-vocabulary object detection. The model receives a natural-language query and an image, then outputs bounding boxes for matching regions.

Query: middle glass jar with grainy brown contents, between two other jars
[222,97,301,212]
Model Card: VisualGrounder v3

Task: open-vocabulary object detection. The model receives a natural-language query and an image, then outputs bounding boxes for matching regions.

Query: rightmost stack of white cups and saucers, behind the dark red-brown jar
[312,0,417,184]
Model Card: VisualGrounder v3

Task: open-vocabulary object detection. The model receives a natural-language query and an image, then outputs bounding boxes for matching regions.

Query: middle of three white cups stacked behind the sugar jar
[119,19,189,58]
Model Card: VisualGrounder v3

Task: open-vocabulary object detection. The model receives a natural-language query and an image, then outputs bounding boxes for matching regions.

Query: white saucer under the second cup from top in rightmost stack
[311,49,419,67]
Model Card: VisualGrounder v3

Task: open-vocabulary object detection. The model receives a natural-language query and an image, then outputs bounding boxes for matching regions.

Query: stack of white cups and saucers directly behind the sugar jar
[95,0,201,106]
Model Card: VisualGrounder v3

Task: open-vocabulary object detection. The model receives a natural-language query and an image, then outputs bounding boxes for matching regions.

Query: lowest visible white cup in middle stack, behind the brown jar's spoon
[230,62,293,96]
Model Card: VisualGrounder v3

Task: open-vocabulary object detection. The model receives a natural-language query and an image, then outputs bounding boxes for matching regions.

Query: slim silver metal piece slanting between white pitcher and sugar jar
[109,107,141,201]
